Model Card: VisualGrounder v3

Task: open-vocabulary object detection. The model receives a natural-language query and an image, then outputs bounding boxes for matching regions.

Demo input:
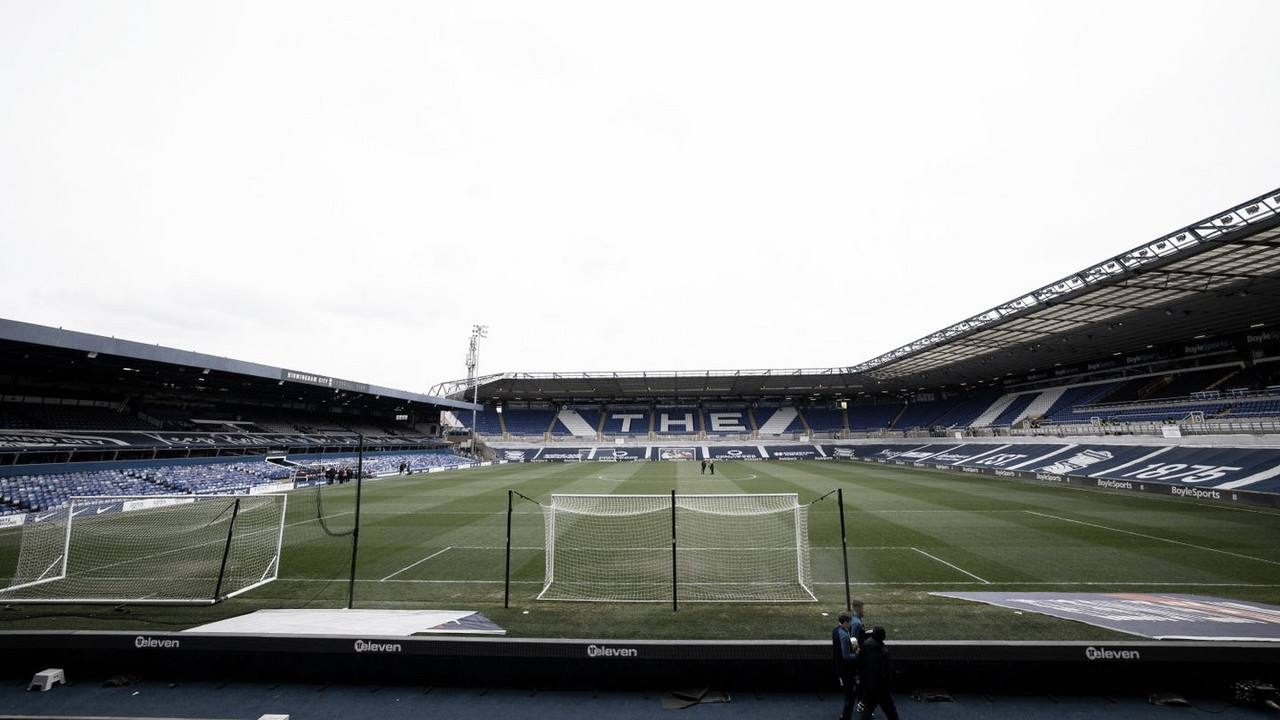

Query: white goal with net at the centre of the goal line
[538,493,817,602]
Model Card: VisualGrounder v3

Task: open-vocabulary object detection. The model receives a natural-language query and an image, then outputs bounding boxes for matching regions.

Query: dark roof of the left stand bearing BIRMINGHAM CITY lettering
[0,319,472,418]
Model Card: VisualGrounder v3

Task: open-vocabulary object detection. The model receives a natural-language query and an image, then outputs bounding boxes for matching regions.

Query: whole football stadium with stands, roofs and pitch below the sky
[0,184,1280,710]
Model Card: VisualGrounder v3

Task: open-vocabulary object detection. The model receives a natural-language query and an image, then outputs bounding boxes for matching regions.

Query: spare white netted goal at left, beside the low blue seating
[0,495,285,605]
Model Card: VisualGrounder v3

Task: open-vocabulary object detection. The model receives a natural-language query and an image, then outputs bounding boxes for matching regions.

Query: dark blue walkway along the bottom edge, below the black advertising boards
[0,678,1276,720]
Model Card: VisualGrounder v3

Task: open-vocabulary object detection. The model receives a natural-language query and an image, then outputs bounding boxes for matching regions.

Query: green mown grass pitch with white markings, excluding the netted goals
[0,461,1280,641]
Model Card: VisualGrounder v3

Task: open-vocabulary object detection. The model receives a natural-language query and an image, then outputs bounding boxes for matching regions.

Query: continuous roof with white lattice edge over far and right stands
[431,184,1280,404]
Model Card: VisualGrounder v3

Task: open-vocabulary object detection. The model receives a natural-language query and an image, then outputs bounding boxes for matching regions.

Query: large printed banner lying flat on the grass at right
[933,592,1280,638]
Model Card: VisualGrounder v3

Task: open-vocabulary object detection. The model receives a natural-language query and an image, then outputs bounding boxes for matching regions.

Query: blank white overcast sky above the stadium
[0,0,1280,392]
